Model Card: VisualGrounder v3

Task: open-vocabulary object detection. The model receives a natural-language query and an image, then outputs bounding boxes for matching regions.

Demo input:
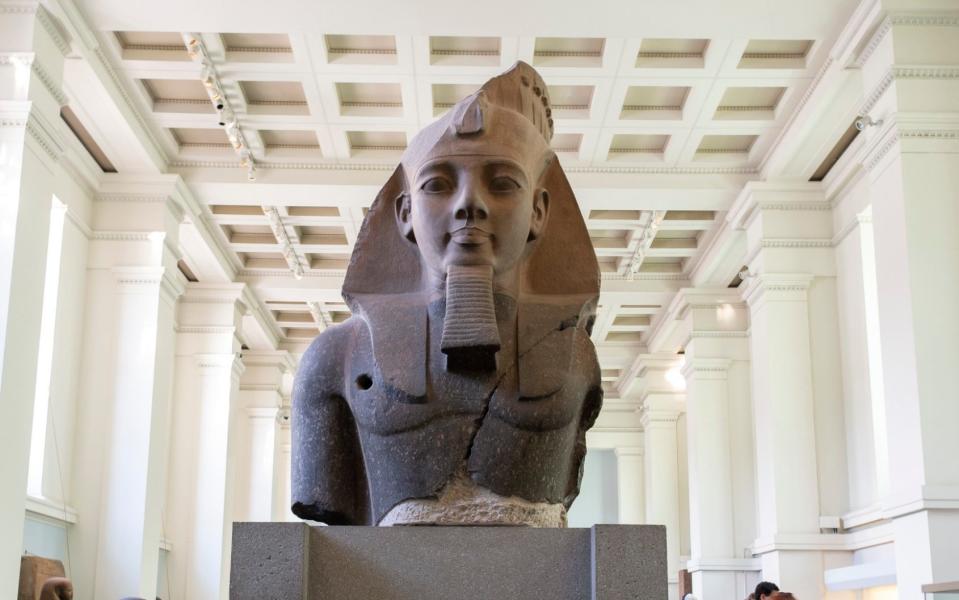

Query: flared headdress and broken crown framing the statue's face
[343,62,600,396]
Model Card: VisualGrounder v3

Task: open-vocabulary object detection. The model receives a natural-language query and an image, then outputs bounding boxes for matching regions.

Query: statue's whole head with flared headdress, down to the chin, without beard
[343,62,599,301]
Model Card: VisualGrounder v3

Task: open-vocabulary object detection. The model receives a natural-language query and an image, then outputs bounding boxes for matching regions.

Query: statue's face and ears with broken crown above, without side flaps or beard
[395,64,555,286]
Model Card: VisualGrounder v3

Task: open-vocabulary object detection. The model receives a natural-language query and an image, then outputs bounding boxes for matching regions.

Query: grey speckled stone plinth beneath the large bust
[230,523,667,600]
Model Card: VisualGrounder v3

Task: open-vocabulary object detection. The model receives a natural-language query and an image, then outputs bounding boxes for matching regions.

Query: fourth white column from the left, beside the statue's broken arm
[234,350,294,521]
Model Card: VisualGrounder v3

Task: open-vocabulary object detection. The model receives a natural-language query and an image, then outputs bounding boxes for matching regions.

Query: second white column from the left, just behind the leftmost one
[69,182,185,599]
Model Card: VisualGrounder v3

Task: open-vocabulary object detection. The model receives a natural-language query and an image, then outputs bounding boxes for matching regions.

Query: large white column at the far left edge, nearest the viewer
[0,1,66,598]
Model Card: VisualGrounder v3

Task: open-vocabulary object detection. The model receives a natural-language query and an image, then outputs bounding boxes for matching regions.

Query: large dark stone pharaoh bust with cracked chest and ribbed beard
[292,63,602,527]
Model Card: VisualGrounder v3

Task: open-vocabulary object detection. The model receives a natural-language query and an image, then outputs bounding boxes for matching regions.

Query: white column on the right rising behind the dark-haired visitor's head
[747,275,823,597]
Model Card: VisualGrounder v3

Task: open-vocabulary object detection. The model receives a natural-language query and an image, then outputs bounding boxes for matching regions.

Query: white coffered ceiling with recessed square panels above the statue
[65,0,854,398]
